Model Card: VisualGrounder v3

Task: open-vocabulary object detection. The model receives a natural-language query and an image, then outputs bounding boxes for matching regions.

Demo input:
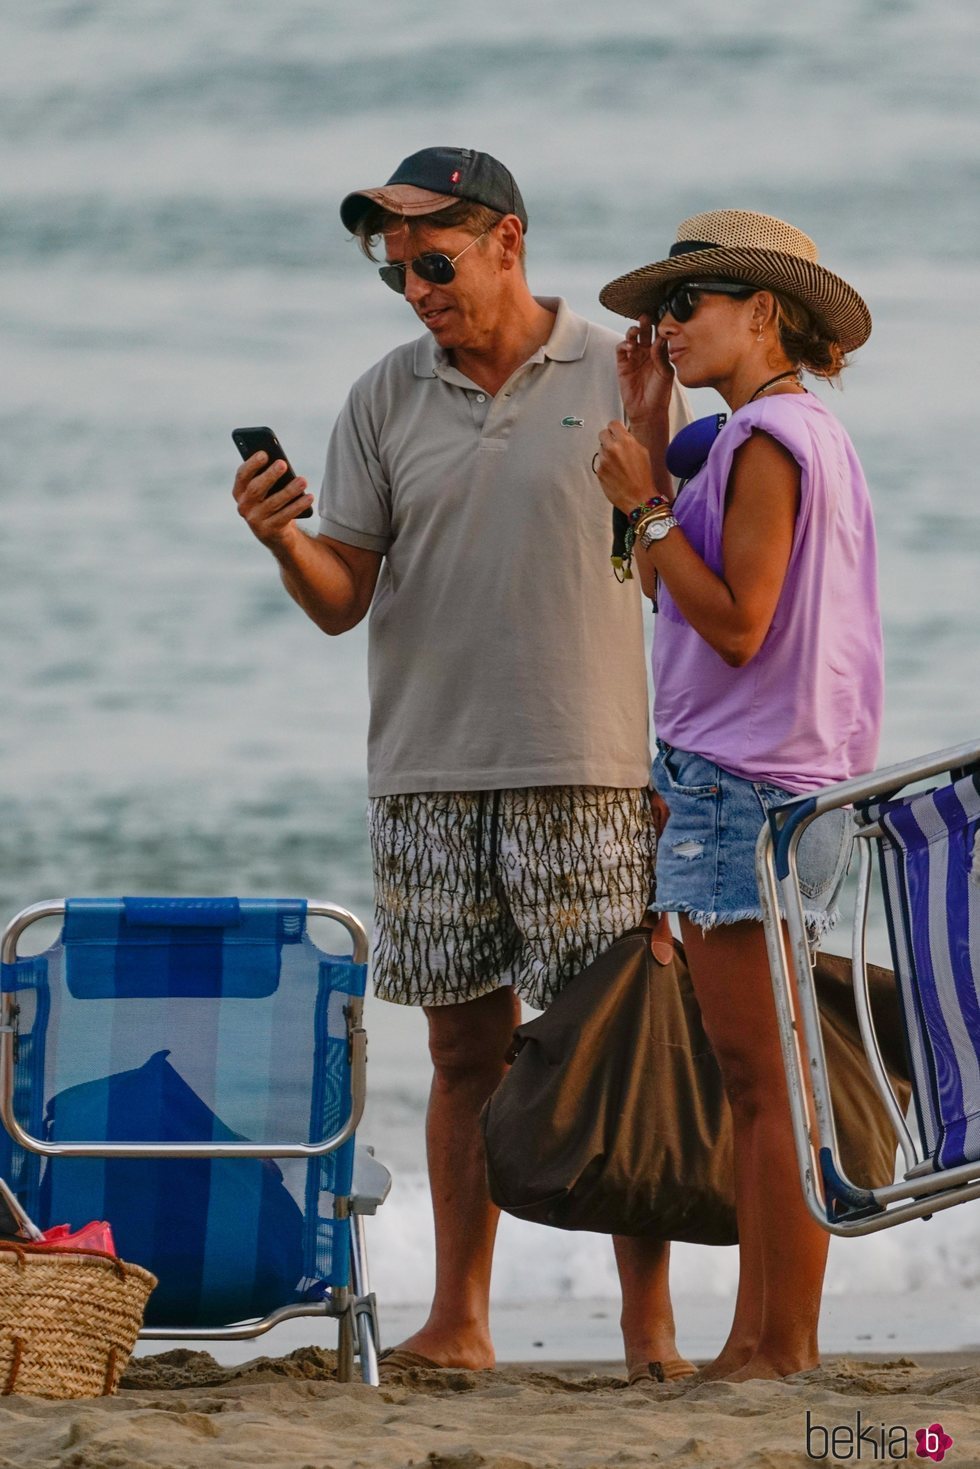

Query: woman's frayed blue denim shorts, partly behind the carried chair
[652,740,851,937]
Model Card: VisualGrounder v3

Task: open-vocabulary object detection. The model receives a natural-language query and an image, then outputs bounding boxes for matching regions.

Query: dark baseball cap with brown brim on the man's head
[341,148,527,234]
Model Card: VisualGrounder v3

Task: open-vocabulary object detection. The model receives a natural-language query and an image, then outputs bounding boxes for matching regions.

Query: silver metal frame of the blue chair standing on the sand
[0,898,391,1387]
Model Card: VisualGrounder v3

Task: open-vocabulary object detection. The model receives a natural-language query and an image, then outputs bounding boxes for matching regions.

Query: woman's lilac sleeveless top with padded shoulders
[654,394,883,792]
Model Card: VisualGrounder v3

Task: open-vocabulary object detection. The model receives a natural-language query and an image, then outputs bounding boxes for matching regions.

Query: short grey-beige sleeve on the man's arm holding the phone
[319,388,391,551]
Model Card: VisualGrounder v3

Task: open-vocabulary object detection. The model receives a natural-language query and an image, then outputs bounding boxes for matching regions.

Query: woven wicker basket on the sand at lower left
[0,1241,156,1397]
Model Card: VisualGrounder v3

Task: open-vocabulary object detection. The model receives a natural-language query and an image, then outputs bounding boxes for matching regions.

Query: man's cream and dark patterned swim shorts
[370,786,657,1009]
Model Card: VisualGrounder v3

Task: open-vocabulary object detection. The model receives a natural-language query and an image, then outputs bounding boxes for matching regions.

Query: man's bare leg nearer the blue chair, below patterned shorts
[390,989,520,1369]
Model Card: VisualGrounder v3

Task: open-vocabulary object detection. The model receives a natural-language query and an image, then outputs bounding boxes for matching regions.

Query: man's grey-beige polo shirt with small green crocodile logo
[319,298,686,796]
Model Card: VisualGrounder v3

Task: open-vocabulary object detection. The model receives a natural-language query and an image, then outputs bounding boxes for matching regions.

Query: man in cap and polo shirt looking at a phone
[235,148,689,1375]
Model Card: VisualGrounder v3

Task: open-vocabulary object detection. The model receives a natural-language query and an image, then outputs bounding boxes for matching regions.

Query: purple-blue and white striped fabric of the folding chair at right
[867,774,980,1169]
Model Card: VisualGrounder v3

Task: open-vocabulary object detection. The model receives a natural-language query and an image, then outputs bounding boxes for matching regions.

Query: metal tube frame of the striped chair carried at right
[755,740,980,1235]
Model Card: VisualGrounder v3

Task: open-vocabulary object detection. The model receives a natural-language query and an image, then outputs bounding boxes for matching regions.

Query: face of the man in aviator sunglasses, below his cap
[385,225,502,350]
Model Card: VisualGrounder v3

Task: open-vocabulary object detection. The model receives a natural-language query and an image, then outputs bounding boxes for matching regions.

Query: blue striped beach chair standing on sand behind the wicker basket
[0,898,389,1385]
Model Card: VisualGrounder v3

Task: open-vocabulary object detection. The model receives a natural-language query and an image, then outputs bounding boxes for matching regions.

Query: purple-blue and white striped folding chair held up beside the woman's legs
[757,742,980,1234]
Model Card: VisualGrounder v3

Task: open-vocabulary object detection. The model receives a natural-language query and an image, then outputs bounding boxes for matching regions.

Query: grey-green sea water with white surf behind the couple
[0,0,980,1340]
